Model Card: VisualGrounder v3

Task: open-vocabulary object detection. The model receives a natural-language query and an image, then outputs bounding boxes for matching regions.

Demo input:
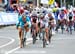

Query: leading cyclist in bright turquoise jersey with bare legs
[16,12,30,48]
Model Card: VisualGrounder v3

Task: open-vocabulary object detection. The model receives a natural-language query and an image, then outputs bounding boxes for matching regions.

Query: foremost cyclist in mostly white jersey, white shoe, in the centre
[40,14,49,45]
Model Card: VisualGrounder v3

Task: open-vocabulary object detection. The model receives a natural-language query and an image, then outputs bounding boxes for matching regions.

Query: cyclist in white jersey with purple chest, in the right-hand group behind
[56,9,66,30]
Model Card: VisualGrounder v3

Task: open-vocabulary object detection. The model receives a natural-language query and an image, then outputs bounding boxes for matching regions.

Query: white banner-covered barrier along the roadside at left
[0,13,18,25]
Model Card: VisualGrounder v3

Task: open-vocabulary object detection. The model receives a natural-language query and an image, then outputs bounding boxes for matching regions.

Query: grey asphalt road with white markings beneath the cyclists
[0,26,75,54]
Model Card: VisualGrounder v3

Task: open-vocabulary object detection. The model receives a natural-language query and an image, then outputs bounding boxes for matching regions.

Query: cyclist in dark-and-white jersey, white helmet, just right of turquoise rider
[31,11,38,40]
